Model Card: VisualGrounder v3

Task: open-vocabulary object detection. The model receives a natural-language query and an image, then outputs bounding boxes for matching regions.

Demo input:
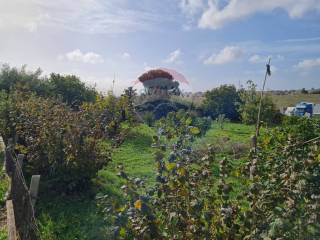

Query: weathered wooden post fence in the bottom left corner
[5,144,40,240]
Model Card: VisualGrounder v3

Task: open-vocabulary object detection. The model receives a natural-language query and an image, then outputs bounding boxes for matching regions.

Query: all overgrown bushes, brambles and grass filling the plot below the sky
[0,62,320,240]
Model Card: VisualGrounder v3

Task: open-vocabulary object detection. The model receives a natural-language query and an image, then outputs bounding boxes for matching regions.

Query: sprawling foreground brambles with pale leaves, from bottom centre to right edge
[108,115,320,240]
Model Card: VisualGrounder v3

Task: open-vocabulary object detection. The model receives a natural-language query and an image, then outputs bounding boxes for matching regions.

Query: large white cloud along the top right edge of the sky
[198,0,320,29]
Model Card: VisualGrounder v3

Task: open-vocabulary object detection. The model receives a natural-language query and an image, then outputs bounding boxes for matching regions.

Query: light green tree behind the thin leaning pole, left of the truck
[239,80,281,124]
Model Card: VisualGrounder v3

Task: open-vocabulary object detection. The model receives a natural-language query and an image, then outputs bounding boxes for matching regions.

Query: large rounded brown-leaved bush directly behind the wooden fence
[0,93,110,192]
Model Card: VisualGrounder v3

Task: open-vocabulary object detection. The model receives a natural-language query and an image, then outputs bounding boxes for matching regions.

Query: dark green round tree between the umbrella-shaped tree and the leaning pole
[202,85,240,120]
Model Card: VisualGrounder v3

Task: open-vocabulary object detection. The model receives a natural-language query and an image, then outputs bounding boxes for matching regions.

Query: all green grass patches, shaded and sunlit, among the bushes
[38,123,254,240]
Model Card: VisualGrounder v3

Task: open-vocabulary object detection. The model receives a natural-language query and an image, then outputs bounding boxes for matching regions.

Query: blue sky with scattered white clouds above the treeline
[0,0,320,93]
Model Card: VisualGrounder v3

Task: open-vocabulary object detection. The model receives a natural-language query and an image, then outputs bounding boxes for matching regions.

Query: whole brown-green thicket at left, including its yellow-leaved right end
[0,89,134,192]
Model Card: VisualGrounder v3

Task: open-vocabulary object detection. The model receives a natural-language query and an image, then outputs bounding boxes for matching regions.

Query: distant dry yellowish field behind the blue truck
[272,93,320,108]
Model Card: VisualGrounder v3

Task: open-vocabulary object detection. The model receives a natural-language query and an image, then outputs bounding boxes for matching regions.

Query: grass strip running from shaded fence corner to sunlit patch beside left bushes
[37,125,154,240]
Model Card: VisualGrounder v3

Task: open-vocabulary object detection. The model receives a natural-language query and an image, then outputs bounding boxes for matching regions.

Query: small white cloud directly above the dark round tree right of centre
[204,46,243,65]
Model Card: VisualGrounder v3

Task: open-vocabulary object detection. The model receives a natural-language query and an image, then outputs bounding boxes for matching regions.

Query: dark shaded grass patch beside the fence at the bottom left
[37,196,108,240]
